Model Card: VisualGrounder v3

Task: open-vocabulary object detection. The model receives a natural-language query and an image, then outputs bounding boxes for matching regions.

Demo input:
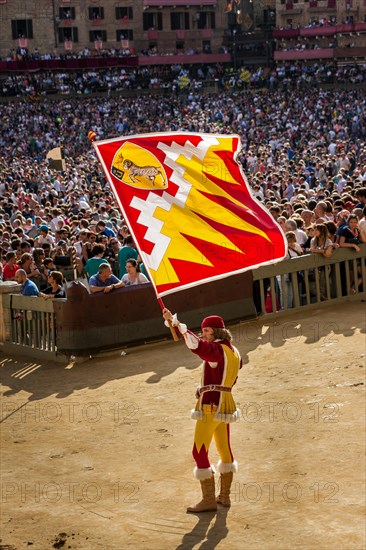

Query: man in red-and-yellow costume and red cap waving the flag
[163,309,242,513]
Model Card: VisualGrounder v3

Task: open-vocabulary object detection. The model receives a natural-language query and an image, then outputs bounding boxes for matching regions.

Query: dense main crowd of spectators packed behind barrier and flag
[0,73,366,308]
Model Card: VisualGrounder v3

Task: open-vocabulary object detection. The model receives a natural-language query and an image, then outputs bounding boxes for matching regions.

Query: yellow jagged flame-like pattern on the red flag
[148,138,269,285]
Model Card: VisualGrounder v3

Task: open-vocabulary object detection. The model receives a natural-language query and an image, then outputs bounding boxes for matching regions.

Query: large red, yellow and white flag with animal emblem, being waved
[93,132,287,297]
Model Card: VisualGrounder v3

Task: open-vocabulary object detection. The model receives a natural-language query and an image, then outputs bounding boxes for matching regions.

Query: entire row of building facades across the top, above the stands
[0,0,366,68]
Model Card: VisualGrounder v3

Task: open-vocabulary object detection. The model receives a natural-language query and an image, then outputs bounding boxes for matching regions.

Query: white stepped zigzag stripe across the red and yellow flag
[131,136,219,270]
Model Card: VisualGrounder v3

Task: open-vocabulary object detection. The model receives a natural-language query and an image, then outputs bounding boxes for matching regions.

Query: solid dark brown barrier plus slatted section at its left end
[4,272,256,359]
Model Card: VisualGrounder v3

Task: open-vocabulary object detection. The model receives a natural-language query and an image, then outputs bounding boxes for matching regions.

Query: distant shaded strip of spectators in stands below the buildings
[0,61,366,99]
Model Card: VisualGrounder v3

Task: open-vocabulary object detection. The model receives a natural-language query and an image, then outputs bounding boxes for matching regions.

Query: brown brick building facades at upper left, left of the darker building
[0,0,232,56]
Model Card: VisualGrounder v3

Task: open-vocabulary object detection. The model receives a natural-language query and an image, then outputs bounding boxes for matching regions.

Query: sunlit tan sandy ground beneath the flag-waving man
[0,302,366,550]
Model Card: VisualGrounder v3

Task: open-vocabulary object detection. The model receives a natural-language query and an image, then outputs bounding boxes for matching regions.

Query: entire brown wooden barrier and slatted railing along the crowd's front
[0,244,366,359]
